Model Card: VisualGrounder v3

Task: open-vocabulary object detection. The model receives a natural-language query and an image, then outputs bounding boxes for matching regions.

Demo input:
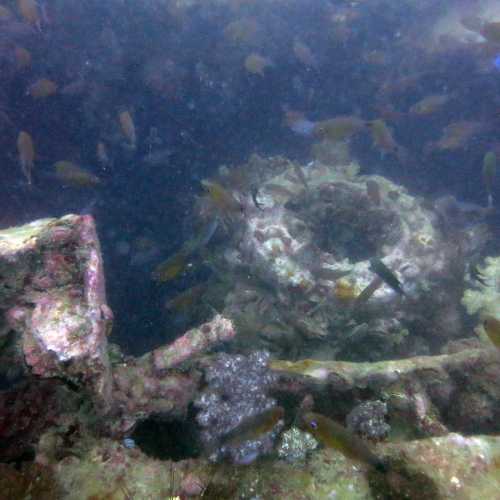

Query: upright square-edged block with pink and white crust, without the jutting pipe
[0,215,111,413]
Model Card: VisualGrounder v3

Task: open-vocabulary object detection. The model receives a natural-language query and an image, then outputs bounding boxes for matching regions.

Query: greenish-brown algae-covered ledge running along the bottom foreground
[8,426,500,500]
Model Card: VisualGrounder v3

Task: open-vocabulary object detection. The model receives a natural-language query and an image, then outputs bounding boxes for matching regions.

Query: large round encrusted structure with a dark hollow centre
[216,158,469,361]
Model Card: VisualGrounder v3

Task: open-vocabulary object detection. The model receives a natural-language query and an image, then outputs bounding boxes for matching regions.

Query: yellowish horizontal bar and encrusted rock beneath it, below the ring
[271,349,500,436]
